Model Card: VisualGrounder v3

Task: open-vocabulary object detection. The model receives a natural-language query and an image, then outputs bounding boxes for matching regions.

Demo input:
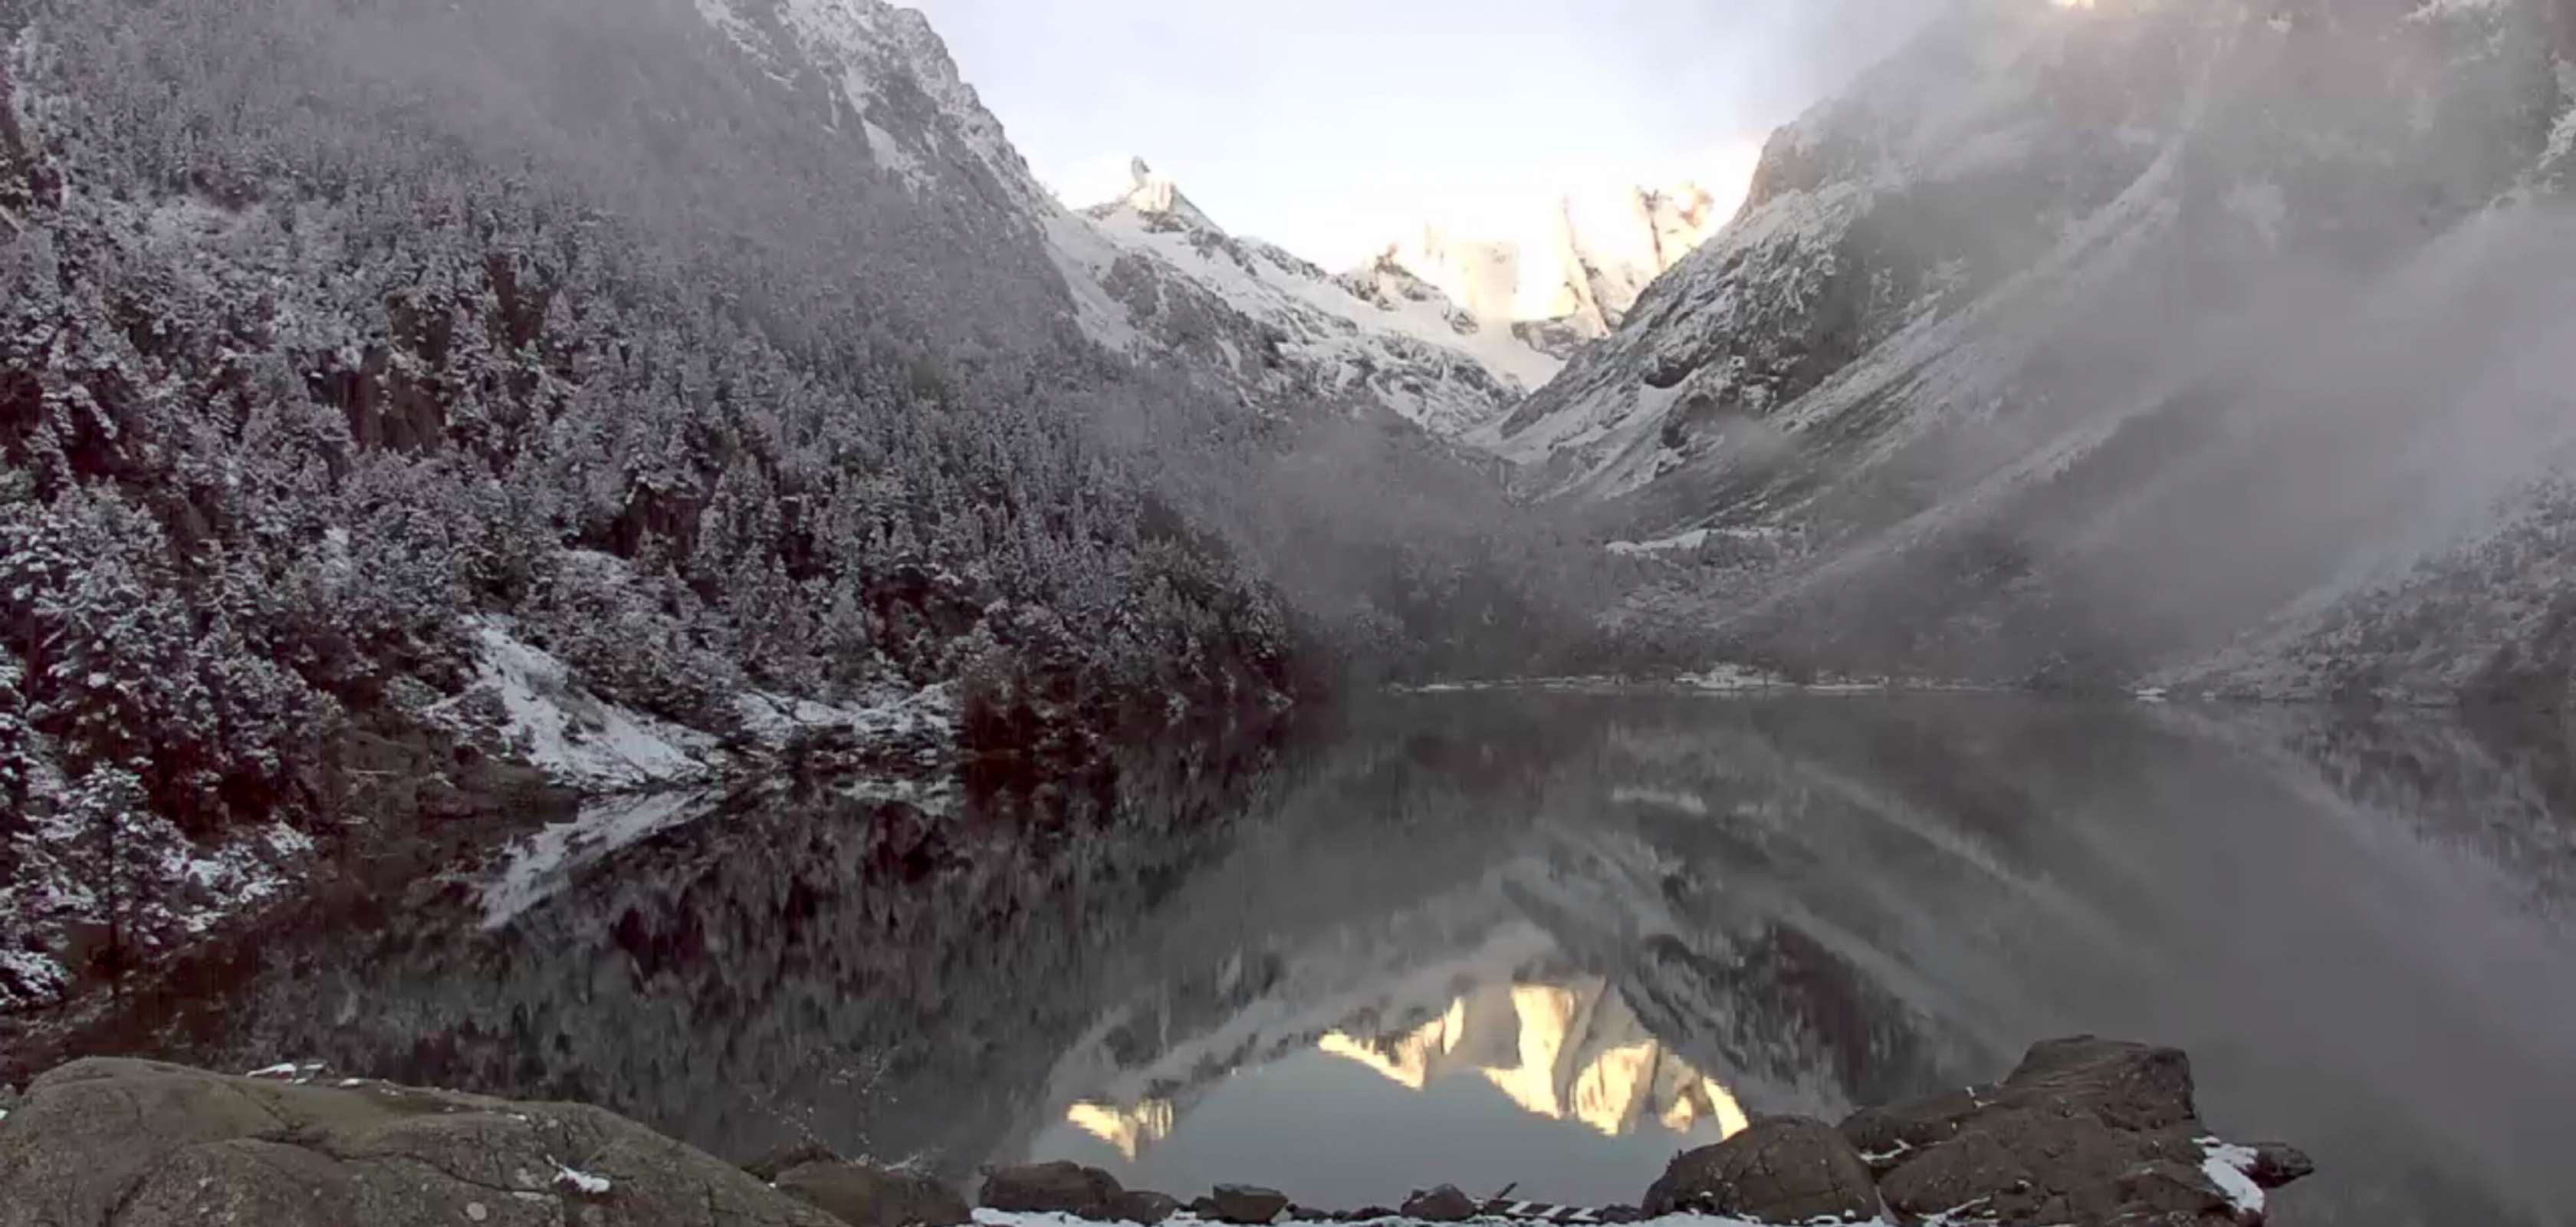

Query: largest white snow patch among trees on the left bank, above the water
[430,619,716,791]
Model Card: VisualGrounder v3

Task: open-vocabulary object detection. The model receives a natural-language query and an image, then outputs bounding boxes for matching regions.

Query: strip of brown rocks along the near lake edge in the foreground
[0,1036,2313,1227]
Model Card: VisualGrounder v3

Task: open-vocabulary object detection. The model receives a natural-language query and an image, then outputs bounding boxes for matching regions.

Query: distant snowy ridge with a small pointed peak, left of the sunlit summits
[1056,160,1561,436]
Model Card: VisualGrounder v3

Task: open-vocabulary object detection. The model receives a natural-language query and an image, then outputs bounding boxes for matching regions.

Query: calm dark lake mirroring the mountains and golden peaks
[55,693,2576,1227]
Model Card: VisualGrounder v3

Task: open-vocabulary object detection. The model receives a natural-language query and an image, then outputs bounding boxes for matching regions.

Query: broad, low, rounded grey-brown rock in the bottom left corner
[0,1060,837,1227]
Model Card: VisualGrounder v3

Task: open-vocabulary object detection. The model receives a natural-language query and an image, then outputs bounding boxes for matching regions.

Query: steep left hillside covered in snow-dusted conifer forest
[0,0,1586,1005]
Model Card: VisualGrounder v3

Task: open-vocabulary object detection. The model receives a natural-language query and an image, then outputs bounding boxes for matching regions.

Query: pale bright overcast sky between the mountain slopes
[912,0,1940,268]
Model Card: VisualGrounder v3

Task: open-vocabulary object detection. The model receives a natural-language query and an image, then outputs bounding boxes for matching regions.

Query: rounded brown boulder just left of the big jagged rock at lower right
[1646,1116,1881,1222]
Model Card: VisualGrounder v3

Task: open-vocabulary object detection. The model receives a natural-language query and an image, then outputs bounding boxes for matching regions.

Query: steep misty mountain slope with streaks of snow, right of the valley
[1491,0,2576,693]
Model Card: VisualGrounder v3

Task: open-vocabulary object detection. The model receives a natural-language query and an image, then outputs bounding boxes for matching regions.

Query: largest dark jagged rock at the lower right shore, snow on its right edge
[1842,1036,2313,1227]
